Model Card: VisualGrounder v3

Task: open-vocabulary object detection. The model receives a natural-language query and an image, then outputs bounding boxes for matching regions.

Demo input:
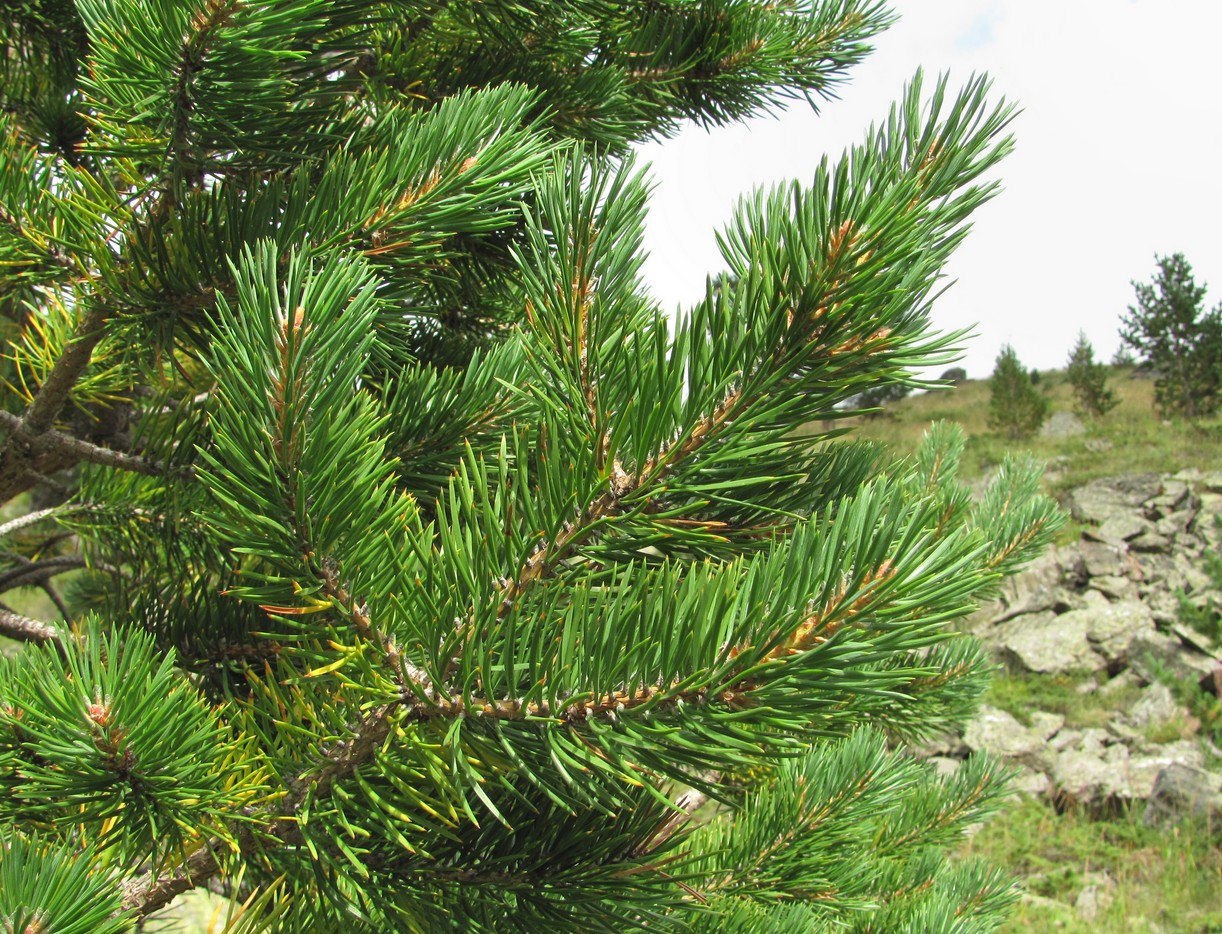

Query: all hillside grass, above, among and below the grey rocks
[854,361,1222,934]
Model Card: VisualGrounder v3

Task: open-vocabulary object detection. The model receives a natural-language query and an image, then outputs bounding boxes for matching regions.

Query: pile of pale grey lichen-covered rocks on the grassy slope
[929,471,1222,823]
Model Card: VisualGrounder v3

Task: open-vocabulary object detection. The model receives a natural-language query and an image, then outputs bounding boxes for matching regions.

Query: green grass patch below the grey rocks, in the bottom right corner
[962,797,1222,934]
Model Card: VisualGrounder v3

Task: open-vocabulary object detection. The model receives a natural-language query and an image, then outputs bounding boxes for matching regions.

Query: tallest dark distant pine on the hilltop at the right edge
[1121,253,1222,418]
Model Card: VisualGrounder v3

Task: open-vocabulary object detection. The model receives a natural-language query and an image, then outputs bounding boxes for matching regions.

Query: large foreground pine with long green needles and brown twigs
[0,0,1058,933]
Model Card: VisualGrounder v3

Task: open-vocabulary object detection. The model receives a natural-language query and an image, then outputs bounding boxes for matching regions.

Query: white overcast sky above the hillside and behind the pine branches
[642,0,1222,378]
